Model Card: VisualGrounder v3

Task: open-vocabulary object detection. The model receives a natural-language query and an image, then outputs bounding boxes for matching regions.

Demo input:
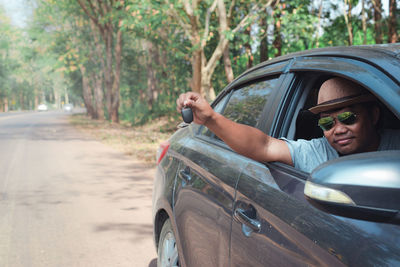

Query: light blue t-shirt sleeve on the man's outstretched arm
[281,138,338,172]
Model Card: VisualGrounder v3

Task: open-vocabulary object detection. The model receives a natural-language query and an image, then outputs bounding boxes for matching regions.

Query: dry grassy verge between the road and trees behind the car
[70,114,180,164]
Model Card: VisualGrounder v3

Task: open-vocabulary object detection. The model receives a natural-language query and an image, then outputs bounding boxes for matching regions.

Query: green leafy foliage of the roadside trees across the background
[0,0,400,119]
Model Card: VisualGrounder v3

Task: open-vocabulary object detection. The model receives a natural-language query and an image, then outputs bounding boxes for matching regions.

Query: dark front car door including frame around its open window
[231,57,400,266]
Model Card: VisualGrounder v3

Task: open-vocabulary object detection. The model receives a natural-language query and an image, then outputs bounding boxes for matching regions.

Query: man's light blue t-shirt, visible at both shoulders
[281,130,400,172]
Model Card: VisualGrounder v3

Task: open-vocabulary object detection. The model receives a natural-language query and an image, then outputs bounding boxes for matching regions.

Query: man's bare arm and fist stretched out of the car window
[176,92,293,166]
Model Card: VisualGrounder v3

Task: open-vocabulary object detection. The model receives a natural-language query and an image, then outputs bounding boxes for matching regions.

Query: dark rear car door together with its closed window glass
[174,76,279,266]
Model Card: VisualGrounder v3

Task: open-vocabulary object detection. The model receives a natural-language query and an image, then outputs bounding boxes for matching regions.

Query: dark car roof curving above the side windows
[235,43,400,83]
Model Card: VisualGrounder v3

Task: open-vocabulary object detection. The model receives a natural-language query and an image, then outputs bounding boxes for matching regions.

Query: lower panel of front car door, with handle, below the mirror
[231,162,400,266]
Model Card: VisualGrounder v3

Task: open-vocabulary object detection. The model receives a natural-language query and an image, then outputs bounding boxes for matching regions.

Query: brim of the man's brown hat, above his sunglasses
[309,94,376,114]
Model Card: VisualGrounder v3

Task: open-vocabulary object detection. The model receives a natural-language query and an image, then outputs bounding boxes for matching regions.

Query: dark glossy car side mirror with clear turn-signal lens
[304,151,400,224]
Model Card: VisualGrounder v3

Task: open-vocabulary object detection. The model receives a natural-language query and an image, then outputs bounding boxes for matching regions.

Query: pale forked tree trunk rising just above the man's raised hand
[169,0,272,100]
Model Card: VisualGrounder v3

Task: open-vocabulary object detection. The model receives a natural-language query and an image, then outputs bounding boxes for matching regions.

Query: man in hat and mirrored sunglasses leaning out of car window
[176,77,400,172]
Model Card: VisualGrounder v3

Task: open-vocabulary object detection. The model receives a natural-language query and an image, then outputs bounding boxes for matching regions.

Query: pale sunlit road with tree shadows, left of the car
[0,111,156,267]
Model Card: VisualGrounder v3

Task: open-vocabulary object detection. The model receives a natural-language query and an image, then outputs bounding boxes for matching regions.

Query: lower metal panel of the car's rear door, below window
[174,134,248,266]
